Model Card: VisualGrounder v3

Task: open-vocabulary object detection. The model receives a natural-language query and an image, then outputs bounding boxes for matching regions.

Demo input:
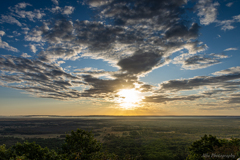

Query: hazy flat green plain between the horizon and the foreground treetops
[0,117,240,159]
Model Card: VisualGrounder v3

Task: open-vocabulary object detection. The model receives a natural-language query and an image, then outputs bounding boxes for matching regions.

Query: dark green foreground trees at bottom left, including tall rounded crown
[0,129,118,160]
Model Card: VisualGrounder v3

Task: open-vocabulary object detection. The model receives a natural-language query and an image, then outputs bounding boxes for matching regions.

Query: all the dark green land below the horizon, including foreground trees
[0,118,240,160]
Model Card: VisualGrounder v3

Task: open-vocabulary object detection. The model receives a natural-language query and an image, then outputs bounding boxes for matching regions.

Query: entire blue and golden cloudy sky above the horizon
[0,0,240,116]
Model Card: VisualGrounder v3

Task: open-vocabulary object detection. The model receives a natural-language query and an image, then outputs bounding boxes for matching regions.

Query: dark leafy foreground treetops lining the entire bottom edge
[0,129,240,160]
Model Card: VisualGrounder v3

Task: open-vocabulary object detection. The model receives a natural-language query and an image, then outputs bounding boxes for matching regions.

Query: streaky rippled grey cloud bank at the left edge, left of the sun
[0,54,81,100]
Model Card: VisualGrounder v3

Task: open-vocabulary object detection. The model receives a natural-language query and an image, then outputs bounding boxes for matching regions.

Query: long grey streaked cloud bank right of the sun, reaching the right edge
[151,67,240,108]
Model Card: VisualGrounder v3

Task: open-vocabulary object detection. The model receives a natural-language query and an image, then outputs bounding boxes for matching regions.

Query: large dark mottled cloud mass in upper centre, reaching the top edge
[34,0,205,66]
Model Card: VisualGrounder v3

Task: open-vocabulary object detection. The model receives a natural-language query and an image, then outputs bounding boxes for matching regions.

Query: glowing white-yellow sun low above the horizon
[117,89,143,109]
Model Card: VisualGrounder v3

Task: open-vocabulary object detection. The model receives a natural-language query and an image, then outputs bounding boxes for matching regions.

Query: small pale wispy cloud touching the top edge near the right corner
[195,0,220,25]
